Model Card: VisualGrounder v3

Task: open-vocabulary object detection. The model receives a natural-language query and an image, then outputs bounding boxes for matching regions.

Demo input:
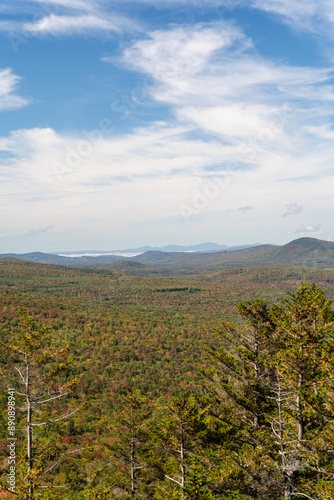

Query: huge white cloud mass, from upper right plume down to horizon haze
[0,18,334,250]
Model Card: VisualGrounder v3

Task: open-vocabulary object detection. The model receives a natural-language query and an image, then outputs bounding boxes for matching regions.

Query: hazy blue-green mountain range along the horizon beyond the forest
[0,238,334,274]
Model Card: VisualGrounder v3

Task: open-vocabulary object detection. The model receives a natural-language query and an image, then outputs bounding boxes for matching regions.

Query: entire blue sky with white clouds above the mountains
[0,0,334,253]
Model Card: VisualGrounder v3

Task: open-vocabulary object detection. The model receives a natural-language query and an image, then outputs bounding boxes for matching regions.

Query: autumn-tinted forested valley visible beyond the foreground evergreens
[0,260,334,398]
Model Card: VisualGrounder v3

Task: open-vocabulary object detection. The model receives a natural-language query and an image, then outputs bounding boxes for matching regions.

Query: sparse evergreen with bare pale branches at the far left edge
[1,311,80,500]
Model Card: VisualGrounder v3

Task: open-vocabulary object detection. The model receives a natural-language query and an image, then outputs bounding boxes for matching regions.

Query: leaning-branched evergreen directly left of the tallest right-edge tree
[204,299,279,499]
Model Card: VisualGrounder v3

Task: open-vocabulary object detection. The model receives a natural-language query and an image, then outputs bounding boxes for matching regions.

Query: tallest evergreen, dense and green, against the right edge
[272,283,334,500]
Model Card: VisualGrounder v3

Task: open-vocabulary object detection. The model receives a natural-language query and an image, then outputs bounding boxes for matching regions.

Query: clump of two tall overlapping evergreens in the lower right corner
[202,284,334,500]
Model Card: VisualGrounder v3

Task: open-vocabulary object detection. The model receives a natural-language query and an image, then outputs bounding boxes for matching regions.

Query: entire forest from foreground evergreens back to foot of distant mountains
[0,260,334,500]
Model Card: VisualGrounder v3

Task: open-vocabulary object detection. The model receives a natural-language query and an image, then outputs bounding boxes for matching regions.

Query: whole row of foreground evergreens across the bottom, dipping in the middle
[1,284,334,500]
